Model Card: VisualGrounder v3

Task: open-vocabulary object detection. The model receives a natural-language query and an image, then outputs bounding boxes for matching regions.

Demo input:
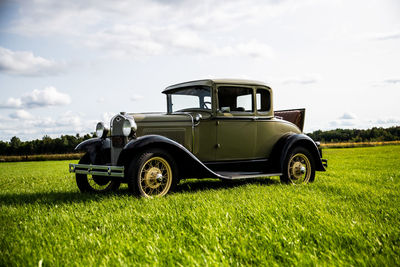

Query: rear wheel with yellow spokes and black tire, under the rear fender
[280,146,315,184]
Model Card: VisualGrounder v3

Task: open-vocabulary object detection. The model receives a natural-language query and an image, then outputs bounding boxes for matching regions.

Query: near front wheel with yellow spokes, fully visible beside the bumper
[127,149,178,198]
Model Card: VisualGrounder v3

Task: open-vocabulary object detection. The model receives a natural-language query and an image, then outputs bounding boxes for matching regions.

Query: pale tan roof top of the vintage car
[163,79,269,94]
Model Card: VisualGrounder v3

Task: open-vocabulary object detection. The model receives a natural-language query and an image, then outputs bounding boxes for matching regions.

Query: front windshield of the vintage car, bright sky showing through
[168,86,211,112]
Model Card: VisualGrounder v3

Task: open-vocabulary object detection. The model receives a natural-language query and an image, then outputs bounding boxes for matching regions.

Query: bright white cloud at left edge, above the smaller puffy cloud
[0,47,64,76]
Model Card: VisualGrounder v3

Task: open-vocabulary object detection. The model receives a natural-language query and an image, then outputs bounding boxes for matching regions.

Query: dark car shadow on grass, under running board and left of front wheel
[0,178,280,206]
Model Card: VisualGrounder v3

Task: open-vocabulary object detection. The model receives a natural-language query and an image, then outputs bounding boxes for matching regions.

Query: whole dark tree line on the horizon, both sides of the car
[0,126,400,156]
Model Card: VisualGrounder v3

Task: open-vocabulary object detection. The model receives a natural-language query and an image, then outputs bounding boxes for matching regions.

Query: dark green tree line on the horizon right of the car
[307,126,400,143]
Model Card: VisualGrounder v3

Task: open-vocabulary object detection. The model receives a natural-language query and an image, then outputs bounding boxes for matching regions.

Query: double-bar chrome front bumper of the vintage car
[69,163,125,177]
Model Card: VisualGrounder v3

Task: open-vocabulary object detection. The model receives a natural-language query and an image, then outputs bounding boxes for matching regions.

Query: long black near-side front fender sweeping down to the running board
[117,135,222,178]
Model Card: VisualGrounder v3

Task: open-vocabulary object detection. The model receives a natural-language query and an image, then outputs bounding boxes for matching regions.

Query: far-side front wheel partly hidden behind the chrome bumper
[75,153,121,193]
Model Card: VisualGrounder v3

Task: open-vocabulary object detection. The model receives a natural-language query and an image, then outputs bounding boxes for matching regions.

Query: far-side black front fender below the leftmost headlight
[75,138,111,162]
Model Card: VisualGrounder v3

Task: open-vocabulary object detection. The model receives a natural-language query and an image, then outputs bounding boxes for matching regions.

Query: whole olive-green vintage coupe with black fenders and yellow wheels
[69,79,327,197]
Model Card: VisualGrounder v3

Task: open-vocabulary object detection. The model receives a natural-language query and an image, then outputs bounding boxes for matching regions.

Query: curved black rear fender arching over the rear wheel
[270,134,325,172]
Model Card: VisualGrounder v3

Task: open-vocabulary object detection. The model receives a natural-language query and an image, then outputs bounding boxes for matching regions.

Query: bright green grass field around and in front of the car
[0,146,400,266]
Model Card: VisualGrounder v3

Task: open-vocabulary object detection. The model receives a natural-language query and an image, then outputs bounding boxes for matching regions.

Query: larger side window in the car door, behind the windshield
[218,86,254,113]
